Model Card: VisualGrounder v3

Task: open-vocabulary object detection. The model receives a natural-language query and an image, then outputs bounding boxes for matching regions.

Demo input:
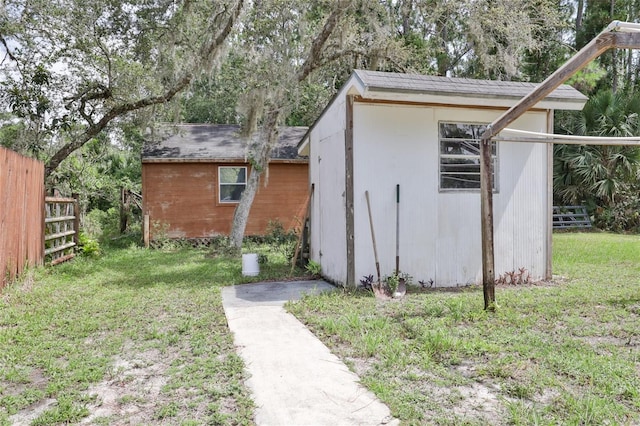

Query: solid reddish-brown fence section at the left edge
[0,147,44,288]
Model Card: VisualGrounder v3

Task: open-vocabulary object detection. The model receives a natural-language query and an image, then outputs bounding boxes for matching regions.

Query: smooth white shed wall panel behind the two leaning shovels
[354,103,437,282]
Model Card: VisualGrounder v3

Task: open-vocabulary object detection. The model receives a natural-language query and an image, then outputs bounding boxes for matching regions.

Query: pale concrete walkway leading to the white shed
[222,281,399,426]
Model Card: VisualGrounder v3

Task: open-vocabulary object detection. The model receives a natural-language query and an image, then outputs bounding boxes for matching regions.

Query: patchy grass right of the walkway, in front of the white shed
[289,233,640,425]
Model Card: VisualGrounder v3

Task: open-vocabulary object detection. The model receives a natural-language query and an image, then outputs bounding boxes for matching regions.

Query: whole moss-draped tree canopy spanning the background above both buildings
[0,0,640,233]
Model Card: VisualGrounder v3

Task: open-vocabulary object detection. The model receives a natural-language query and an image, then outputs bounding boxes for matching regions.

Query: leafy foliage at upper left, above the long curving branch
[0,0,243,176]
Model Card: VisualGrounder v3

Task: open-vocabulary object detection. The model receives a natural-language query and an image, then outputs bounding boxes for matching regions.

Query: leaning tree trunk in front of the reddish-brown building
[229,109,280,250]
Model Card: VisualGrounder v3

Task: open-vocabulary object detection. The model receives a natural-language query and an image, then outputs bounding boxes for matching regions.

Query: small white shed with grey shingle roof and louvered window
[299,70,587,287]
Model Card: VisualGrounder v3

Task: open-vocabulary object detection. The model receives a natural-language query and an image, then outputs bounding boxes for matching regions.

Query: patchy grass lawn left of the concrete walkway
[0,240,304,426]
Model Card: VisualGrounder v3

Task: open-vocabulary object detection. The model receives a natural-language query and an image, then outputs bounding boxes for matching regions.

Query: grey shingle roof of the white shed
[354,70,587,101]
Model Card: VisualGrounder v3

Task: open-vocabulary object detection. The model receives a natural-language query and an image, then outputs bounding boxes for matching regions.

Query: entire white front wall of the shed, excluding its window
[350,103,550,286]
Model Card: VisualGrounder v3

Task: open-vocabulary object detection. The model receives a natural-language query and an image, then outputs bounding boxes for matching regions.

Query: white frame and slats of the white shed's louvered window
[438,121,499,193]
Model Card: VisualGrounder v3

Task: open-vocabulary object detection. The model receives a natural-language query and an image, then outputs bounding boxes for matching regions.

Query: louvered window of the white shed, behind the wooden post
[440,123,498,191]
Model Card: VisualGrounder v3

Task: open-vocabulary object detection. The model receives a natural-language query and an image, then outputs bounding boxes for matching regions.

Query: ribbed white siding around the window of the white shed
[436,108,547,286]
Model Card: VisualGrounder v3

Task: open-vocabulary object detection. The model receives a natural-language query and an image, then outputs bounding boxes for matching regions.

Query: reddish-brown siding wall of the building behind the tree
[142,163,309,239]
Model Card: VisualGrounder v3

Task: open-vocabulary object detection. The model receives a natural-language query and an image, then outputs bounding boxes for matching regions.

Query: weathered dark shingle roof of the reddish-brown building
[142,124,308,162]
